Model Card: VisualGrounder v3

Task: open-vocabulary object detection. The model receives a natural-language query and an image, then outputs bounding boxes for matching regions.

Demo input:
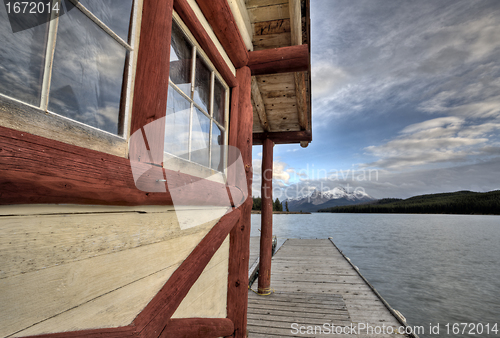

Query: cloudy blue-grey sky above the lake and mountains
[254,0,500,199]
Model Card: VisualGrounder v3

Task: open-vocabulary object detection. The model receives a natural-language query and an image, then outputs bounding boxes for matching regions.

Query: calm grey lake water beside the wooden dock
[252,213,500,337]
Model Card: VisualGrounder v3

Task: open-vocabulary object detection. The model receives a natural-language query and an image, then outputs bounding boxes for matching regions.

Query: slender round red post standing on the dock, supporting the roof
[258,138,274,294]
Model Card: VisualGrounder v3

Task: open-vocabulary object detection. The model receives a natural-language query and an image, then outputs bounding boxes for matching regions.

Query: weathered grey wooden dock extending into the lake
[247,239,416,338]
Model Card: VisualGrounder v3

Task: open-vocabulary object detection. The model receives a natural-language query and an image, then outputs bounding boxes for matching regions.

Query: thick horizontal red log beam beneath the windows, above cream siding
[0,127,241,206]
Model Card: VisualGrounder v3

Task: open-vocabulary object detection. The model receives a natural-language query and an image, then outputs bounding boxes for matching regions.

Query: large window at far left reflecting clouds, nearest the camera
[0,0,134,136]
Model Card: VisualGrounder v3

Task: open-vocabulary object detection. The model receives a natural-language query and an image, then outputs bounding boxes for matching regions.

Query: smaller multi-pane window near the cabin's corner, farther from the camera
[165,20,229,171]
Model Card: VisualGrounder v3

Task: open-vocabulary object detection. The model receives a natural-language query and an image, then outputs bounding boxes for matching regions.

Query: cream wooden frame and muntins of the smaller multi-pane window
[168,10,230,173]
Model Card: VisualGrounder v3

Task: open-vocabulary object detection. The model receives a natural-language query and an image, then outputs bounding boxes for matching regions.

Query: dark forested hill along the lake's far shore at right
[320,190,500,215]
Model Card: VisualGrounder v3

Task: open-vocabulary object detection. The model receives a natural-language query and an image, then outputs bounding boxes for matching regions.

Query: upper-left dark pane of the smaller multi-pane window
[169,22,193,97]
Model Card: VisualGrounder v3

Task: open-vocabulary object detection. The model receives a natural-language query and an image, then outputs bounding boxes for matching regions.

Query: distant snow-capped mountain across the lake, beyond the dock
[283,187,374,212]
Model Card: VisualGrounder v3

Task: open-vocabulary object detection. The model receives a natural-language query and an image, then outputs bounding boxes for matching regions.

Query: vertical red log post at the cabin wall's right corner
[227,67,253,338]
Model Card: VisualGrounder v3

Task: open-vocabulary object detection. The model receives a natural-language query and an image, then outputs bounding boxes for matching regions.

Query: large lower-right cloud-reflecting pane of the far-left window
[49,9,127,134]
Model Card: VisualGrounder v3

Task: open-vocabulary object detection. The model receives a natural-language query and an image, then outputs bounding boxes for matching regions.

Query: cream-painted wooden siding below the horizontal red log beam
[0,205,229,337]
